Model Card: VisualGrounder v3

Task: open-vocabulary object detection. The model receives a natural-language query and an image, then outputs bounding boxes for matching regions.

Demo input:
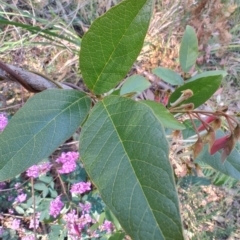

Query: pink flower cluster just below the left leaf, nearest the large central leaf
[56,152,79,174]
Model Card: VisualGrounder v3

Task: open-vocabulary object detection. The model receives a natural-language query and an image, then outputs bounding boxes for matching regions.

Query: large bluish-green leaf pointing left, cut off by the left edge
[0,89,91,181]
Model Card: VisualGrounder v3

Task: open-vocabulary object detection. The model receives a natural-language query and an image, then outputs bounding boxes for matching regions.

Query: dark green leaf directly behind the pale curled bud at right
[169,75,222,108]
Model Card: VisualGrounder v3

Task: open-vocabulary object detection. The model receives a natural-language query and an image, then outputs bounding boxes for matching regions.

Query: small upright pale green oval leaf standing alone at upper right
[179,26,198,72]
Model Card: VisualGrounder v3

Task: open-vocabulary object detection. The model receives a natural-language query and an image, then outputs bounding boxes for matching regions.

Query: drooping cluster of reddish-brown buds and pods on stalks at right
[169,89,240,162]
